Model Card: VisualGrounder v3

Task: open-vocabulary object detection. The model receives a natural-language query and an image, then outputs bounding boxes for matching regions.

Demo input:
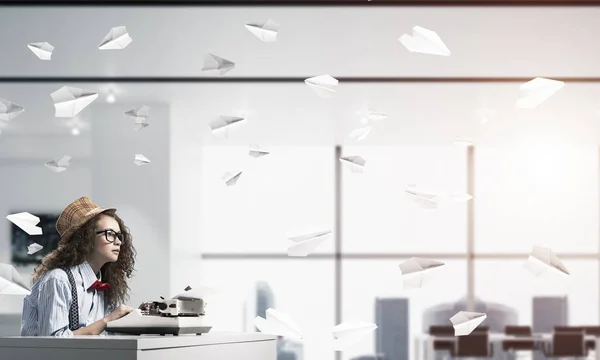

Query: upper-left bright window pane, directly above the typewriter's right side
[200,146,334,254]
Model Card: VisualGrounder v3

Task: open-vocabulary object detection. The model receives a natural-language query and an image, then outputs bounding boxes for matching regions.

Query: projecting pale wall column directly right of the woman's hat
[91,103,170,307]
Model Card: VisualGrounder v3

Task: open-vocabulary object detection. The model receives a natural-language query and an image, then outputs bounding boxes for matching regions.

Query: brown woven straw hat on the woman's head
[56,196,116,243]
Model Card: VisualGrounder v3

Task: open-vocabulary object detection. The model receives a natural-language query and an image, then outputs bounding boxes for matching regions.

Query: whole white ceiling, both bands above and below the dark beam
[0,7,600,144]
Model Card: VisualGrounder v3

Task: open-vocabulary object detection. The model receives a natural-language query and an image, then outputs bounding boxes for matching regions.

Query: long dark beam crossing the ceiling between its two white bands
[0,75,600,83]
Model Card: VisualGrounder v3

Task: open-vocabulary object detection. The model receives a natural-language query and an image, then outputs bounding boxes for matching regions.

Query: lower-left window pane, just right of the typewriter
[201,259,335,360]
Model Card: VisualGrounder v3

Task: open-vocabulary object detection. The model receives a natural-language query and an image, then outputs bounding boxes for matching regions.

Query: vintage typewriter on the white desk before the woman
[106,286,212,335]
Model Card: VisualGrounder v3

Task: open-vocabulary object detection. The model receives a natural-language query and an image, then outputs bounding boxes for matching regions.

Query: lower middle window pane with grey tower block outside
[342,259,467,360]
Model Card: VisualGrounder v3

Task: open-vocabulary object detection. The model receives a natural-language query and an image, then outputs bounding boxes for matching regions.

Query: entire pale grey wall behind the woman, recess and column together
[0,100,170,313]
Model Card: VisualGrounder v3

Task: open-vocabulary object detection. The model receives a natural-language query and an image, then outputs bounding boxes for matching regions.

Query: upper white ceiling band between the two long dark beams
[0,7,600,77]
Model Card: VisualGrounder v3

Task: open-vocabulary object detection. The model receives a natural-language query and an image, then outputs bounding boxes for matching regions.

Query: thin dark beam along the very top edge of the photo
[0,0,600,7]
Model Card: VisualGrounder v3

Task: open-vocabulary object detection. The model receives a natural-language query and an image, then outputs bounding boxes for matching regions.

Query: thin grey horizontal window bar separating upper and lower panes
[202,253,600,261]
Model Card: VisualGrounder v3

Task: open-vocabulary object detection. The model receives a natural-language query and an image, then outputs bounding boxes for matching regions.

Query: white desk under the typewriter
[0,332,277,360]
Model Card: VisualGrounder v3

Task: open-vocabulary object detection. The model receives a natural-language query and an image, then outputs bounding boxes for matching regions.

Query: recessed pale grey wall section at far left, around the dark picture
[0,135,92,335]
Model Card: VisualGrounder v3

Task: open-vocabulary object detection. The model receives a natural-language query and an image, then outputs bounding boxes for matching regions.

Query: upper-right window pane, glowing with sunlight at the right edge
[475,146,599,253]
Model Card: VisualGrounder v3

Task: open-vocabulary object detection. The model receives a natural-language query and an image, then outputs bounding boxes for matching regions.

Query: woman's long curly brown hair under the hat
[32,210,136,306]
